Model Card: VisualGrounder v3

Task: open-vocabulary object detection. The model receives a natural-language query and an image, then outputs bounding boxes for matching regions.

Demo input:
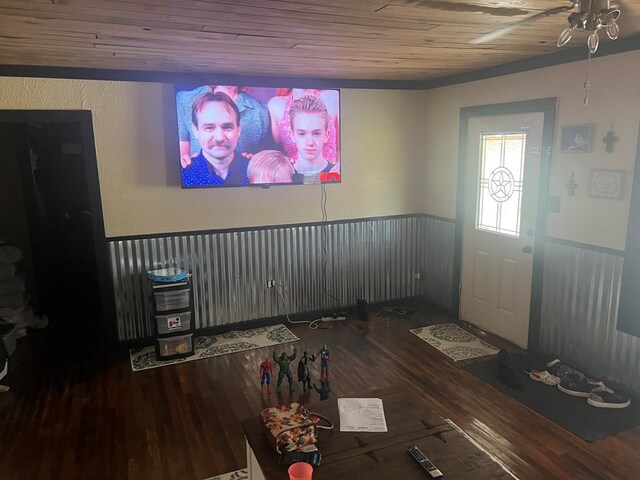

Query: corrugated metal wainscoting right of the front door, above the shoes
[540,241,640,393]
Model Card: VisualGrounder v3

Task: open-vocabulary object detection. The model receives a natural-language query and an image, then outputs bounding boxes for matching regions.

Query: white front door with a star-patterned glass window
[460,112,544,348]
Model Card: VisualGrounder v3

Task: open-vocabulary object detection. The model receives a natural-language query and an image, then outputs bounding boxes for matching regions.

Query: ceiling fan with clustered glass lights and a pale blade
[469,0,620,53]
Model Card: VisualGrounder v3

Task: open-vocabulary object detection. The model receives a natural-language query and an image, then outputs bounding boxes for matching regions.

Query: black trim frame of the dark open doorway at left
[0,110,116,345]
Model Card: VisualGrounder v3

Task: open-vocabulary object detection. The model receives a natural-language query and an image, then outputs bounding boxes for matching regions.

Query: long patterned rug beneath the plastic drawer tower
[129,325,300,372]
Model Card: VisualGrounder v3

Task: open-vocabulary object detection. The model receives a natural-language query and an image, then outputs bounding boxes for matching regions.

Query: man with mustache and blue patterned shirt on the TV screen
[182,92,248,187]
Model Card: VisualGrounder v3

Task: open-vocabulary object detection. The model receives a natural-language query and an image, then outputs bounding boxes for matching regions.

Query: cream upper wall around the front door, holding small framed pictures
[421,49,640,250]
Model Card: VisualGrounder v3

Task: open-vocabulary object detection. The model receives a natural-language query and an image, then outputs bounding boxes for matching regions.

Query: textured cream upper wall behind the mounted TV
[0,77,424,237]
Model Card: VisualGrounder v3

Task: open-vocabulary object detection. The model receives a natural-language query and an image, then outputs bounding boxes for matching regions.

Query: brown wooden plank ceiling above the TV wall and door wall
[0,0,640,80]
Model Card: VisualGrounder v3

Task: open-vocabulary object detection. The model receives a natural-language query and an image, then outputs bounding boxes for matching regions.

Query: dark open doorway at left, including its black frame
[0,111,112,351]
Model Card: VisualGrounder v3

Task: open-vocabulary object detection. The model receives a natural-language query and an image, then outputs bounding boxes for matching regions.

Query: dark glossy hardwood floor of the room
[0,306,640,480]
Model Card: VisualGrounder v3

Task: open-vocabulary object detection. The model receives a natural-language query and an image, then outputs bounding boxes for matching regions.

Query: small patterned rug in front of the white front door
[411,323,498,362]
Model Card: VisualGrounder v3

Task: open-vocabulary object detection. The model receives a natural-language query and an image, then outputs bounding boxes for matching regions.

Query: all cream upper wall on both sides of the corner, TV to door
[0,51,640,249]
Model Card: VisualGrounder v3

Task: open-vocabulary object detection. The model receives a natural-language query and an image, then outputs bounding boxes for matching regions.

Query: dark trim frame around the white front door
[452,98,556,350]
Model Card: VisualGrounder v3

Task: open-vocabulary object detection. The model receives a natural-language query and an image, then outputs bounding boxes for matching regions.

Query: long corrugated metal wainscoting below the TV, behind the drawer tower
[109,215,454,340]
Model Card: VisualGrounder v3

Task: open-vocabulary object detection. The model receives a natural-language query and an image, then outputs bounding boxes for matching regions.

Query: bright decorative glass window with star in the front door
[476,132,527,237]
